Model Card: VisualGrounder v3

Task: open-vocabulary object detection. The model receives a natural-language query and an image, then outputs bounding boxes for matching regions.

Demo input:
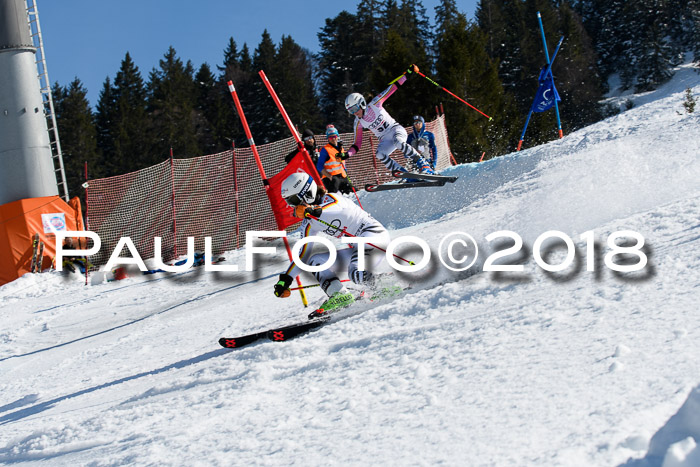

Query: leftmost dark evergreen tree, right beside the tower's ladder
[52,78,104,196]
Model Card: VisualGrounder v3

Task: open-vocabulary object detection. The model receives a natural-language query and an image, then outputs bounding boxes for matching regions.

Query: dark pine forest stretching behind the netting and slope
[52,0,700,199]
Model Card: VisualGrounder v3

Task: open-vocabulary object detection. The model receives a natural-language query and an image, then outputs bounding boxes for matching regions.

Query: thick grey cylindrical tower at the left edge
[0,0,58,205]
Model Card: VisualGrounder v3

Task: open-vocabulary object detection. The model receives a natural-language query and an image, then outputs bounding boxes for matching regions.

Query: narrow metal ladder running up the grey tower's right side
[27,0,68,202]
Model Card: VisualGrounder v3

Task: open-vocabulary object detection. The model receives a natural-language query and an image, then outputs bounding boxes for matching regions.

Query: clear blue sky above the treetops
[36,0,477,107]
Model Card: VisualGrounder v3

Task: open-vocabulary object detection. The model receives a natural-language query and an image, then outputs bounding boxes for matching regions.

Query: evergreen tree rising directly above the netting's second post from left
[148,47,202,159]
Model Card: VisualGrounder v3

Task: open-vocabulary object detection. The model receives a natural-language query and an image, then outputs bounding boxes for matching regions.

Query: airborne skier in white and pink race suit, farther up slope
[345,65,435,174]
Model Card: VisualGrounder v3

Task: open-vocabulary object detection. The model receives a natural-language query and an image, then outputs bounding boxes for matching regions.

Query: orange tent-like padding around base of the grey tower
[0,196,85,285]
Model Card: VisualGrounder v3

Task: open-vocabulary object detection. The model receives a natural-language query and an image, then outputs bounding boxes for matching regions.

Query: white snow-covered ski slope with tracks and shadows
[0,64,700,466]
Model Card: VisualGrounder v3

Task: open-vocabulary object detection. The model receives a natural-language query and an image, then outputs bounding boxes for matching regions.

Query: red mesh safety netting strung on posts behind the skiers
[87,115,452,265]
